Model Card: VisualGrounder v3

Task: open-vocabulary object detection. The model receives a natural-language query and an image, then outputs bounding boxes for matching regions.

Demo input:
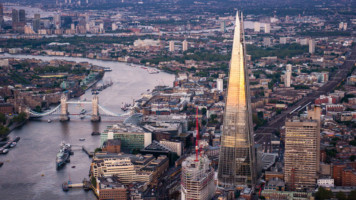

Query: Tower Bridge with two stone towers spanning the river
[27,94,130,122]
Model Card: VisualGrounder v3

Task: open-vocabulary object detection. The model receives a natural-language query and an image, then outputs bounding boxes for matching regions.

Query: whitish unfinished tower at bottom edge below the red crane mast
[181,155,216,200]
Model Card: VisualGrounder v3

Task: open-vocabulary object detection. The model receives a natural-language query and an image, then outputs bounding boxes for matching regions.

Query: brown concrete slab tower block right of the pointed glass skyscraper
[284,107,321,190]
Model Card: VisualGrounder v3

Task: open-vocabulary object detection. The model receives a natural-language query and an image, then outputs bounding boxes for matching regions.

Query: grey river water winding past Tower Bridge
[0,54,174,200]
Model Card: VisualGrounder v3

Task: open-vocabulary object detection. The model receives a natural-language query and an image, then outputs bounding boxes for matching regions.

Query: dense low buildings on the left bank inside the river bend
[0,58,104,114]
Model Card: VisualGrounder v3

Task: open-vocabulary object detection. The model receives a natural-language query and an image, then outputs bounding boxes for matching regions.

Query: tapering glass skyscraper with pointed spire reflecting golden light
[218,14,256,188]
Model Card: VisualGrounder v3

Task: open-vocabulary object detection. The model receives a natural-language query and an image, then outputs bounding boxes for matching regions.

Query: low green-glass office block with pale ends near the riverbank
[100,123,152,153]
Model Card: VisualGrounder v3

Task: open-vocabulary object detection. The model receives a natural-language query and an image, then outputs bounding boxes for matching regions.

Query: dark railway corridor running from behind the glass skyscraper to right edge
[255,46,356,149]
